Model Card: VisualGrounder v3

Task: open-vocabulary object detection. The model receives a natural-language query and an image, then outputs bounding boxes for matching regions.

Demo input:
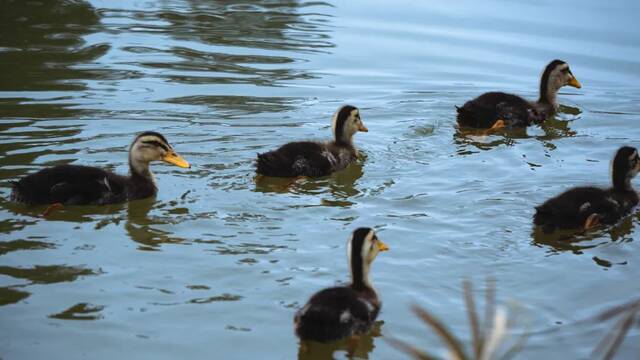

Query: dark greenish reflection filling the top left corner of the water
[0,0,104,92]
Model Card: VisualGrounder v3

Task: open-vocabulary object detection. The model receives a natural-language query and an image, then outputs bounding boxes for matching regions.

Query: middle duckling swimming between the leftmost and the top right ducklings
[256,105,369,177]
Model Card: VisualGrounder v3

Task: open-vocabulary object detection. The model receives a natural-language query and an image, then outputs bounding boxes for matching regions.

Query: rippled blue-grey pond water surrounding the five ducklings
[0,0,640,359]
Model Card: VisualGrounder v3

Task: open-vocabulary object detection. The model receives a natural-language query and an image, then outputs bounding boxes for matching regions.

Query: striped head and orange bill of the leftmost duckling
[129,131,190,175]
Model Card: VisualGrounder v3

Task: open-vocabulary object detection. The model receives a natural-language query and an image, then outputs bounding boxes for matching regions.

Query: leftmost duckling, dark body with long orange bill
[11,131,189,207]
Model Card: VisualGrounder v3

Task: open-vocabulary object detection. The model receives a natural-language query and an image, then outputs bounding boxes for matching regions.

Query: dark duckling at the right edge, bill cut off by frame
[533,146,640,232]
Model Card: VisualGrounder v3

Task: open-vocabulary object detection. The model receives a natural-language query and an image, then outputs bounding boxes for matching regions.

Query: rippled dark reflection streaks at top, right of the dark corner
[104,0,335,94]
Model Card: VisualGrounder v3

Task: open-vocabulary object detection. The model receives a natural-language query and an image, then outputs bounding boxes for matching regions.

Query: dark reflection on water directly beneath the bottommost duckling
[298,320,384,360]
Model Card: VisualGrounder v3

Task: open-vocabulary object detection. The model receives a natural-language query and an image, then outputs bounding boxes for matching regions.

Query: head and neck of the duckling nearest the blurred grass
[347,228,389,289]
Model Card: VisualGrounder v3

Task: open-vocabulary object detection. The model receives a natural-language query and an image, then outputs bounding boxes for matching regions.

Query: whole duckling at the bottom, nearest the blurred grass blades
[294,228,389,342]
